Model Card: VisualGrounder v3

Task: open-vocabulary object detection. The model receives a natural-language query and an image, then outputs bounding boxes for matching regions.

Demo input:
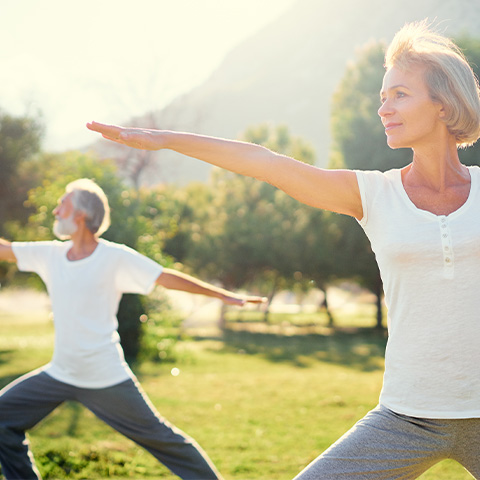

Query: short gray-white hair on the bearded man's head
[65,178,110,237]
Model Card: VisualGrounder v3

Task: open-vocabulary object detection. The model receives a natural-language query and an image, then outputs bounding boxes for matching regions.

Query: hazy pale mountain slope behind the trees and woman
[89,0,480,184]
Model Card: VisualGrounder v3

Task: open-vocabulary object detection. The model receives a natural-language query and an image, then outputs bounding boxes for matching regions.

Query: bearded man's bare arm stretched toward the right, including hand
[155,268,267,306]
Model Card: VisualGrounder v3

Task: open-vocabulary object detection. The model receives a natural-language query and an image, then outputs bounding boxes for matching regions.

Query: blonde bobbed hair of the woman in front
[385,20,480,147]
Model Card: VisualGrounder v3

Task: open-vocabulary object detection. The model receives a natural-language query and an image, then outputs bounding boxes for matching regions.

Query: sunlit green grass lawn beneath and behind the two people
[0,315,472,480]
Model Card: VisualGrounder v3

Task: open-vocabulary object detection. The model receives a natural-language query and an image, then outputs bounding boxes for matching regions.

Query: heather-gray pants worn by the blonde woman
[295,406,480,480]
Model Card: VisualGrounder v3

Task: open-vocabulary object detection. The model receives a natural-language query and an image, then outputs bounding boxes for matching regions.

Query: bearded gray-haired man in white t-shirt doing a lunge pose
[0,179,263,480]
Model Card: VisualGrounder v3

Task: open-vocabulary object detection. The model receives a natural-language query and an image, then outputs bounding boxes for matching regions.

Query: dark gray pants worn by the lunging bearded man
[0,371,221,480]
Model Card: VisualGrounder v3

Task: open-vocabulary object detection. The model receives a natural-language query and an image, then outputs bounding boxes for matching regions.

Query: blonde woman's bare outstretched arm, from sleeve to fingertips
[87,122,363,218]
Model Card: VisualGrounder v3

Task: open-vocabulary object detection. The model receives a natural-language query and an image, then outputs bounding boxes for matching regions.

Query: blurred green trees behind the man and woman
[0,37,480,356]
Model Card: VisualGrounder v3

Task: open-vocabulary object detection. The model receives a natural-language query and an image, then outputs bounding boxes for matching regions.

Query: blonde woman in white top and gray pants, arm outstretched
[88,22,480,480]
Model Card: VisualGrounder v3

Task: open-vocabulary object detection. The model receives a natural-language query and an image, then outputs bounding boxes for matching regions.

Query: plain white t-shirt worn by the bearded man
[12,239,162,388]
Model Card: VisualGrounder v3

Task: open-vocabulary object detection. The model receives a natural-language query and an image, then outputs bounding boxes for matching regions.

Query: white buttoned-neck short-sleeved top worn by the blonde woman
[357,167,480,418]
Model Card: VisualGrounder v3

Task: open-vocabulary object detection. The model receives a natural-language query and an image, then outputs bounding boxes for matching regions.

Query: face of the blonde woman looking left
[378,66,447,149]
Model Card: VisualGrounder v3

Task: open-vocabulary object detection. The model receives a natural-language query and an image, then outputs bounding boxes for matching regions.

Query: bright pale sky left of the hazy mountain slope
[0,0,296,152]
